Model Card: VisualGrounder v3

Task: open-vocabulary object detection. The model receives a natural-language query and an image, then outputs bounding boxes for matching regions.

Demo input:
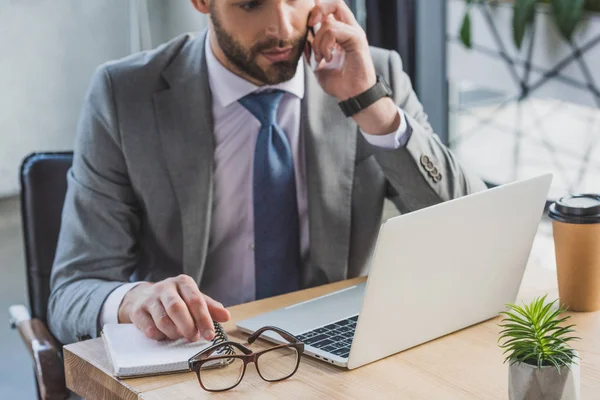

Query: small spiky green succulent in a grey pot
[498,296,580,400]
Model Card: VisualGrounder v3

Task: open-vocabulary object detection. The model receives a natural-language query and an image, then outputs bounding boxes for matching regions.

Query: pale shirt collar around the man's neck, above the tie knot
[204,33,304,107]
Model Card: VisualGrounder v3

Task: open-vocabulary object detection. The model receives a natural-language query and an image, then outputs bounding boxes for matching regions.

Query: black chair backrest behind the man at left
[21,153,73,323]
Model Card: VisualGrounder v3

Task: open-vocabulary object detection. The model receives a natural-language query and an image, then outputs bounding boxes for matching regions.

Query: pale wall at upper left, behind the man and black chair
[0,0,205,197]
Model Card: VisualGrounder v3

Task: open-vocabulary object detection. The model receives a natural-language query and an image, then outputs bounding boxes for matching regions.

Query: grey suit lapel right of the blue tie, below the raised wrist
[302,65,357,286]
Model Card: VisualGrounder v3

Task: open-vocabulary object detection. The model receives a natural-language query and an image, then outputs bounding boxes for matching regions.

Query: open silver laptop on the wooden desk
[237,175,552,369]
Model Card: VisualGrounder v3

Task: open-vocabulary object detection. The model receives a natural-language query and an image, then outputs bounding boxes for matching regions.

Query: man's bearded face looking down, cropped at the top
[210,0,314,85]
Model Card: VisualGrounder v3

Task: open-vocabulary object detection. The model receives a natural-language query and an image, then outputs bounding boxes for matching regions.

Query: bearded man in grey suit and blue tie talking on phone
[48,0,485,343]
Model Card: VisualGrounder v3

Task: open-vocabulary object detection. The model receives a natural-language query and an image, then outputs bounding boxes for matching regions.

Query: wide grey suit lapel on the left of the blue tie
[154,35,214,282]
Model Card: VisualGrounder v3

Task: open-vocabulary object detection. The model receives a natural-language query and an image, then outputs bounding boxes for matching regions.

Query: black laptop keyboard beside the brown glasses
[298,315,358,358]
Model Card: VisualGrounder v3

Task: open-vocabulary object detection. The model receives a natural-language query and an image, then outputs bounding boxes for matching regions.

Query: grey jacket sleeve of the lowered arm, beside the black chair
[48,67,140,344]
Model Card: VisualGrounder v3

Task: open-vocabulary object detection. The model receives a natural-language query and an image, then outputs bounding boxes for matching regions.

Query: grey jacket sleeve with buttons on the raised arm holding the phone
[371,50,486,213]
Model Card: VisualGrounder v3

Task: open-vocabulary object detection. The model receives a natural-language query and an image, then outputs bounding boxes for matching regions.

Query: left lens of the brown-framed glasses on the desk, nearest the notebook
[198,346,244,391]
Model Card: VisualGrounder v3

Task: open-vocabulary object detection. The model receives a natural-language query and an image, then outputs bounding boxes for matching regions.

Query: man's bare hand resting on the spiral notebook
[119,275,230,342]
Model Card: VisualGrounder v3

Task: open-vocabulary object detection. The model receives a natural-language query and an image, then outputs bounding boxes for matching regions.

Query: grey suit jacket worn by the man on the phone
[48,34,485,343]
